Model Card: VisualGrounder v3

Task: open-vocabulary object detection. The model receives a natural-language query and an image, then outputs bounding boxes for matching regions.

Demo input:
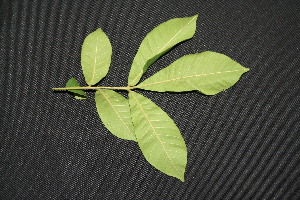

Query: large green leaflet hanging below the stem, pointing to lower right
[129,91,187,181]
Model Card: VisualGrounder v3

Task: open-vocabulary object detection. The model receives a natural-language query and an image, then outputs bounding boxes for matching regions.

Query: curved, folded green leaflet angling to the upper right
[128,15,198,86]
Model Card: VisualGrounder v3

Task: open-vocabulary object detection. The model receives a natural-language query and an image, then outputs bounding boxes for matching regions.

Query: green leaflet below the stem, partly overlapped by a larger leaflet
[95,89,136,141]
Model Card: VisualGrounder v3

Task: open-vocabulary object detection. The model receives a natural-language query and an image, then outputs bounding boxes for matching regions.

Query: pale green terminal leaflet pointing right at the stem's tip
[137,51,249,95]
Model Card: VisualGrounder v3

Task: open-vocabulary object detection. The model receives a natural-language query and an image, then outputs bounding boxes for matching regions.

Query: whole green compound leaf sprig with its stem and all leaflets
[53,15,249,181]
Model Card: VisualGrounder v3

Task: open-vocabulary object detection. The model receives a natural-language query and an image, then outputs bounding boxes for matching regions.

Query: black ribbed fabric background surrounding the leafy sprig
[0,0,300,200]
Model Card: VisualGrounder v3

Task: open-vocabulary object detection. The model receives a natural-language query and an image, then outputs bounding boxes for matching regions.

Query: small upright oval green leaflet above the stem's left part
[81,28,112,85]
